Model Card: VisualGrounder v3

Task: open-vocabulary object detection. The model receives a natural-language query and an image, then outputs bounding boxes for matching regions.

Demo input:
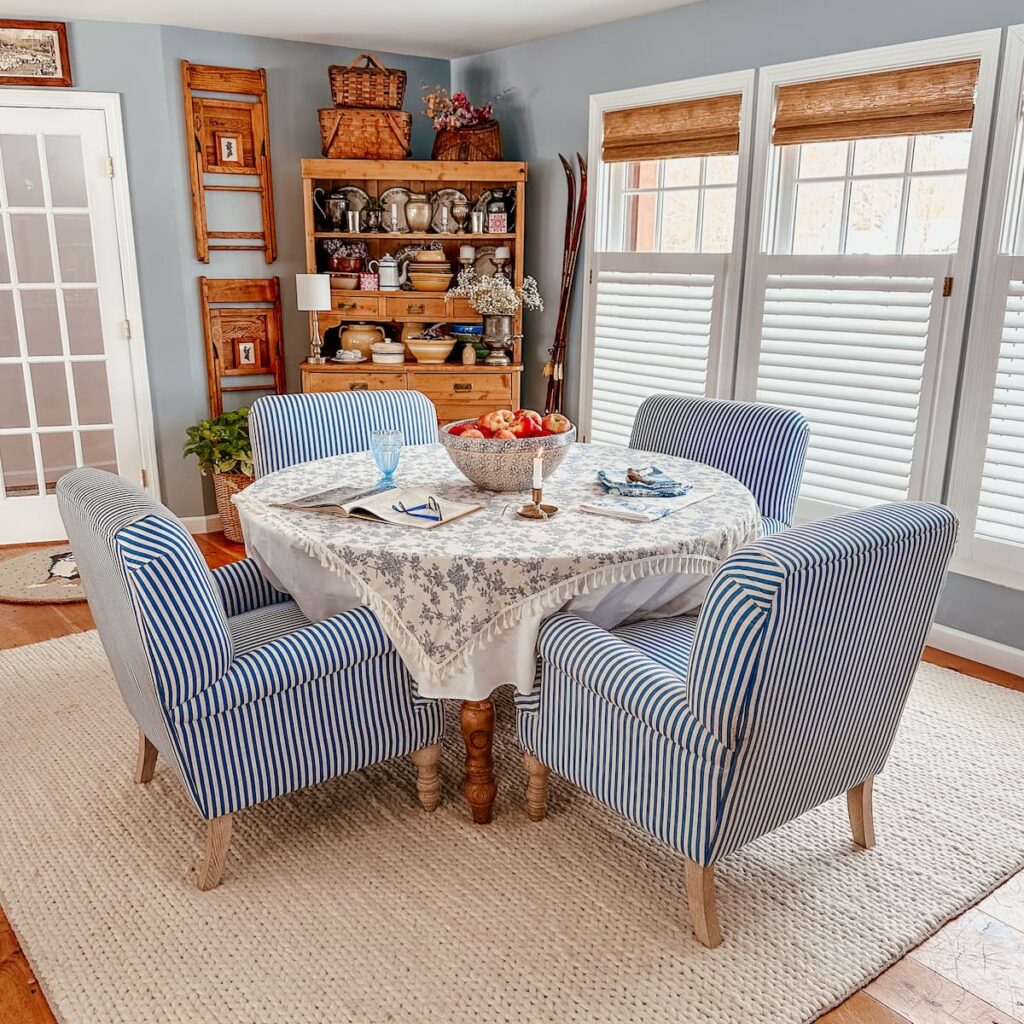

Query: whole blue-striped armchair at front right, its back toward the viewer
[517,503,956,946]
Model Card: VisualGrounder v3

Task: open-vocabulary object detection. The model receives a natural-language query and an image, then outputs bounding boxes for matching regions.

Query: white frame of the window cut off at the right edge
[947,25,1024,590]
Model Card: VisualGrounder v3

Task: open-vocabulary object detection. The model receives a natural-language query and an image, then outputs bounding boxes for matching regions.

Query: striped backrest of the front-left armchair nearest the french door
[57,469,232,749]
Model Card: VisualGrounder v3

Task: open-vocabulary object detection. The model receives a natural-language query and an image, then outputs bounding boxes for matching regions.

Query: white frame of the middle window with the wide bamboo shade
[735,29,1002,519]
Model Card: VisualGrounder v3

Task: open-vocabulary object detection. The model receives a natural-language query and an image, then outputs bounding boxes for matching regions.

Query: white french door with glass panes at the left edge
[0,95,151,544]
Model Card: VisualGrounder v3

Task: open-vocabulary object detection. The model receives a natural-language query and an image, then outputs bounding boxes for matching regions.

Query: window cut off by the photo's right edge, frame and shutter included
[950,27,1024,586]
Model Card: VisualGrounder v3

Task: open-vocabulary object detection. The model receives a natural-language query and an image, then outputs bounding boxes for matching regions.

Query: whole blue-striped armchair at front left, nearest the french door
[57,469,443,890]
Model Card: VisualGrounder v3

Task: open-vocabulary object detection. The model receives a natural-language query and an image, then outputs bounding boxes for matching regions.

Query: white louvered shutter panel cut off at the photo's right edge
[974,268,1024,550]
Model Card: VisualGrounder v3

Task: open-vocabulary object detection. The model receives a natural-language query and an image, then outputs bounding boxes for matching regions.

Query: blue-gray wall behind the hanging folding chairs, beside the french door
[61,20,450,516]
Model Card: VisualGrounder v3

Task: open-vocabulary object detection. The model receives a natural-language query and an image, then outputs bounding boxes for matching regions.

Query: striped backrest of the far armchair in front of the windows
[630,394,809,525]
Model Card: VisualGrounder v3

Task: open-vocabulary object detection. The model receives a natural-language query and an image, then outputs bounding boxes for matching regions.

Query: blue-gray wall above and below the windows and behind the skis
[452,0,1024,647]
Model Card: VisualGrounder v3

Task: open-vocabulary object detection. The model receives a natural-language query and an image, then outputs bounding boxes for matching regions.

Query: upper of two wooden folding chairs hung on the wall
[181,60,278,263]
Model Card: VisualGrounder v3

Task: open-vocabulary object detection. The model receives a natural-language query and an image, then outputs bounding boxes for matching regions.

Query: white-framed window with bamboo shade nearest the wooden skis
[580,73,753,443]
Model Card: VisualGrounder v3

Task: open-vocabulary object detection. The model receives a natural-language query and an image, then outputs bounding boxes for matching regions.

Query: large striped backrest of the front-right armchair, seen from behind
[688,502,956,862]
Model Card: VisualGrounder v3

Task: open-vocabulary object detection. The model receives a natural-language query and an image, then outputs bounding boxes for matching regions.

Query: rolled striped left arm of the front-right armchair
[538,614,707,752]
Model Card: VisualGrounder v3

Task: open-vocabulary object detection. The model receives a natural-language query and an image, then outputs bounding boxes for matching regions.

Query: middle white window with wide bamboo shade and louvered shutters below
[736,33,998,518]
